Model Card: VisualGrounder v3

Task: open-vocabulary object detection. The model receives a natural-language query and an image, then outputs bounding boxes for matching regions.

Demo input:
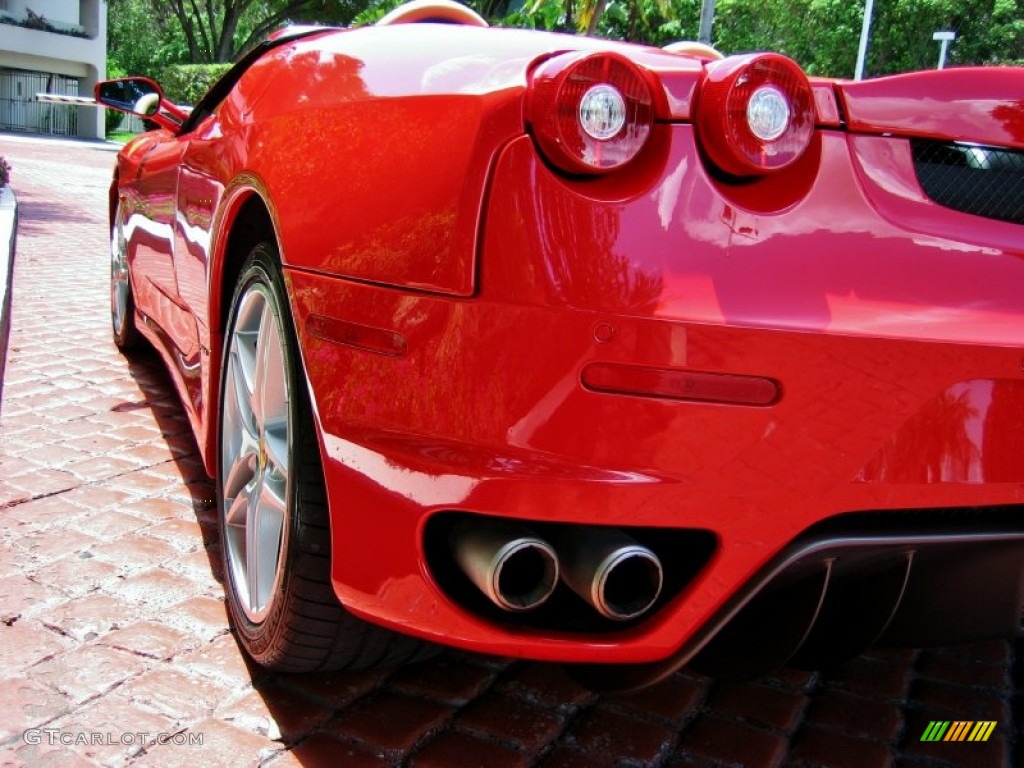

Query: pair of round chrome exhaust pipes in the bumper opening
[452,518,664,622]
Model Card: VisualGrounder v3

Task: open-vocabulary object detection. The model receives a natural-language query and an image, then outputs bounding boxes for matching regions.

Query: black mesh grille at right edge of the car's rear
[910,139,1024,224]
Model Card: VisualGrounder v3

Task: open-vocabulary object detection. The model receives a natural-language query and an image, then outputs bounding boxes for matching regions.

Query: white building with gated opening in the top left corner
[0,0,106,138]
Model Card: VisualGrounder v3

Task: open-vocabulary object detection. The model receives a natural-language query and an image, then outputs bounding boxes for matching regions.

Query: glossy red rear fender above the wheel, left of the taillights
[238,26,536,296]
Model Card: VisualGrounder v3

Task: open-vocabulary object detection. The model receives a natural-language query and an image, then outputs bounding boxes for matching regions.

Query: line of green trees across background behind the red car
[109,0,1024,77]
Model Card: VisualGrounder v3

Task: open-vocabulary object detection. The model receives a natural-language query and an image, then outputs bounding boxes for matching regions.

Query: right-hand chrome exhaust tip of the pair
[558,528,665,622]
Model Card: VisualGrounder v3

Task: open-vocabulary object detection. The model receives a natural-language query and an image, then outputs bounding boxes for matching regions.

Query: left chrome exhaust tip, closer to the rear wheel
[452,518,558,611]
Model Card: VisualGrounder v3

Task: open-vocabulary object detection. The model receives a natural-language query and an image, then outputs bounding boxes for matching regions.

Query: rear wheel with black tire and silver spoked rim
[217,243,434,672]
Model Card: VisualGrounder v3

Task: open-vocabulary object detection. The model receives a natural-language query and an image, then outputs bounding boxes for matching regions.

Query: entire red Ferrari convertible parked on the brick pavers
[96,0,1024,687]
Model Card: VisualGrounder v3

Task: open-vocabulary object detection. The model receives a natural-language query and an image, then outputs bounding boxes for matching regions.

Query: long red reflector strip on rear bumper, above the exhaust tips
[581,362,779,406]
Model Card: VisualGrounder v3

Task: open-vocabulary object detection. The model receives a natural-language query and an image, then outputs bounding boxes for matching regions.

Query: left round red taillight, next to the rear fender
[526,53,654,174]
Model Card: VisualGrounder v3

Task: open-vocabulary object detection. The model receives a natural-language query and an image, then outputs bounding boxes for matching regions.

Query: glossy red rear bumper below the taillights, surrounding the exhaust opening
[288,126,1024,663]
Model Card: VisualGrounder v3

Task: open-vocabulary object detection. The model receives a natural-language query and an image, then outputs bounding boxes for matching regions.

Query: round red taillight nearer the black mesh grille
[696,53,814,176]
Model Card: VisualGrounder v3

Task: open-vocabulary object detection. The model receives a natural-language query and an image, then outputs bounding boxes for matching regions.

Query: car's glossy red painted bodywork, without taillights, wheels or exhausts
[110,20,1024,663]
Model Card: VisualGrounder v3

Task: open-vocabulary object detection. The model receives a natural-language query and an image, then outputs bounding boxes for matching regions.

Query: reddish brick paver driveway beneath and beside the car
[0,136,1024,768]
